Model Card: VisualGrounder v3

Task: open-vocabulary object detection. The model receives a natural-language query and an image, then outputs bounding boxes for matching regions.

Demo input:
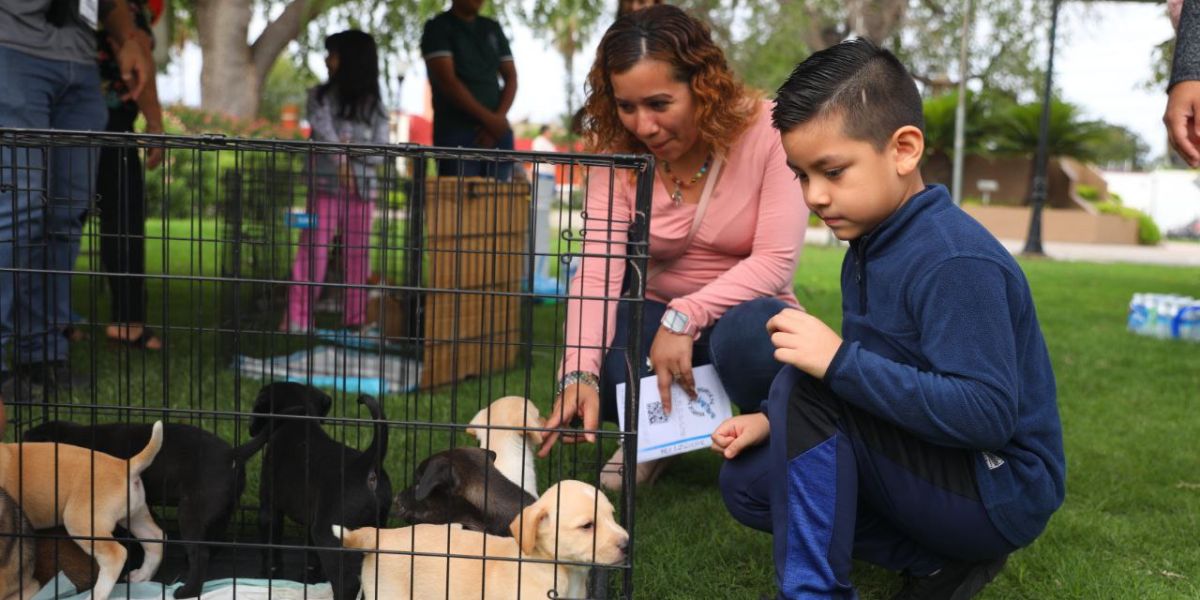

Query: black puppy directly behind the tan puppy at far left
[22,421,268,598]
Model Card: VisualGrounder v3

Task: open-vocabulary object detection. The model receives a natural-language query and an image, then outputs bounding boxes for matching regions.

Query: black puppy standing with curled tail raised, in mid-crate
[250,382,391,600]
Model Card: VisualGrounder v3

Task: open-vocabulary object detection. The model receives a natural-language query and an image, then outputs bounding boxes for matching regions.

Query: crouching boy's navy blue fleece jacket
[826,186,1066,546]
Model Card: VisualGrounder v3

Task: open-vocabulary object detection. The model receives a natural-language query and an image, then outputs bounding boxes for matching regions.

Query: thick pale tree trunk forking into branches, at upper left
[196,0,312,119]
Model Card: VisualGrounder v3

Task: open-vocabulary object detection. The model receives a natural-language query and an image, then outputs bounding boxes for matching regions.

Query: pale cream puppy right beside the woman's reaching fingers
[467,396,546,498]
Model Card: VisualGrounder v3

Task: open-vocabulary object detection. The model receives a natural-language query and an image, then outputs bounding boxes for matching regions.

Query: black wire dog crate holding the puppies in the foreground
[0,130,653,600]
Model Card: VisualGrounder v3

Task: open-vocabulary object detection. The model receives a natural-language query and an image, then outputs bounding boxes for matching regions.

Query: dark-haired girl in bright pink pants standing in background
[280,30,388,331]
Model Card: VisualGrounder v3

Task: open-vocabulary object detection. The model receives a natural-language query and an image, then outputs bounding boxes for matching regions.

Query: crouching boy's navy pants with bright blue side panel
[720,366,1016,600]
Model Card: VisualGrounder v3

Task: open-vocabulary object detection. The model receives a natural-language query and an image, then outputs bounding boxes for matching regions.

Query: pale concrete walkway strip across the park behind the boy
[804,227,1200,268]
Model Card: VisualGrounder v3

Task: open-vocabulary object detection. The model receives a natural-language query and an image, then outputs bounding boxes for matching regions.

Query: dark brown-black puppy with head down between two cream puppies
[395,448,536,538]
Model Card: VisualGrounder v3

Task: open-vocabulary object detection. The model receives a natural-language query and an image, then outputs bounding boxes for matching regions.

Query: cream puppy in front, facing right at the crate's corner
[334,480,629,600]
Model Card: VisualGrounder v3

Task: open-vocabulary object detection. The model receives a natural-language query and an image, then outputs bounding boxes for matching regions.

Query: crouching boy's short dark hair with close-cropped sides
[772,37,925,150]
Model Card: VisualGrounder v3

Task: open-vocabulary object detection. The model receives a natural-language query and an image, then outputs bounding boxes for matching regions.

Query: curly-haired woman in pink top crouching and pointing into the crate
[541,5,808,488]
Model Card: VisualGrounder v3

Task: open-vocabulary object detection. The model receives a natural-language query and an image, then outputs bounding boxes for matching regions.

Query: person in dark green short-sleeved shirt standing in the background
[421,0,517,180]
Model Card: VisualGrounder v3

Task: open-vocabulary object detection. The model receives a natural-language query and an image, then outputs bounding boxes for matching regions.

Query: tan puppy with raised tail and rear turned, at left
[0,421,163,600]
